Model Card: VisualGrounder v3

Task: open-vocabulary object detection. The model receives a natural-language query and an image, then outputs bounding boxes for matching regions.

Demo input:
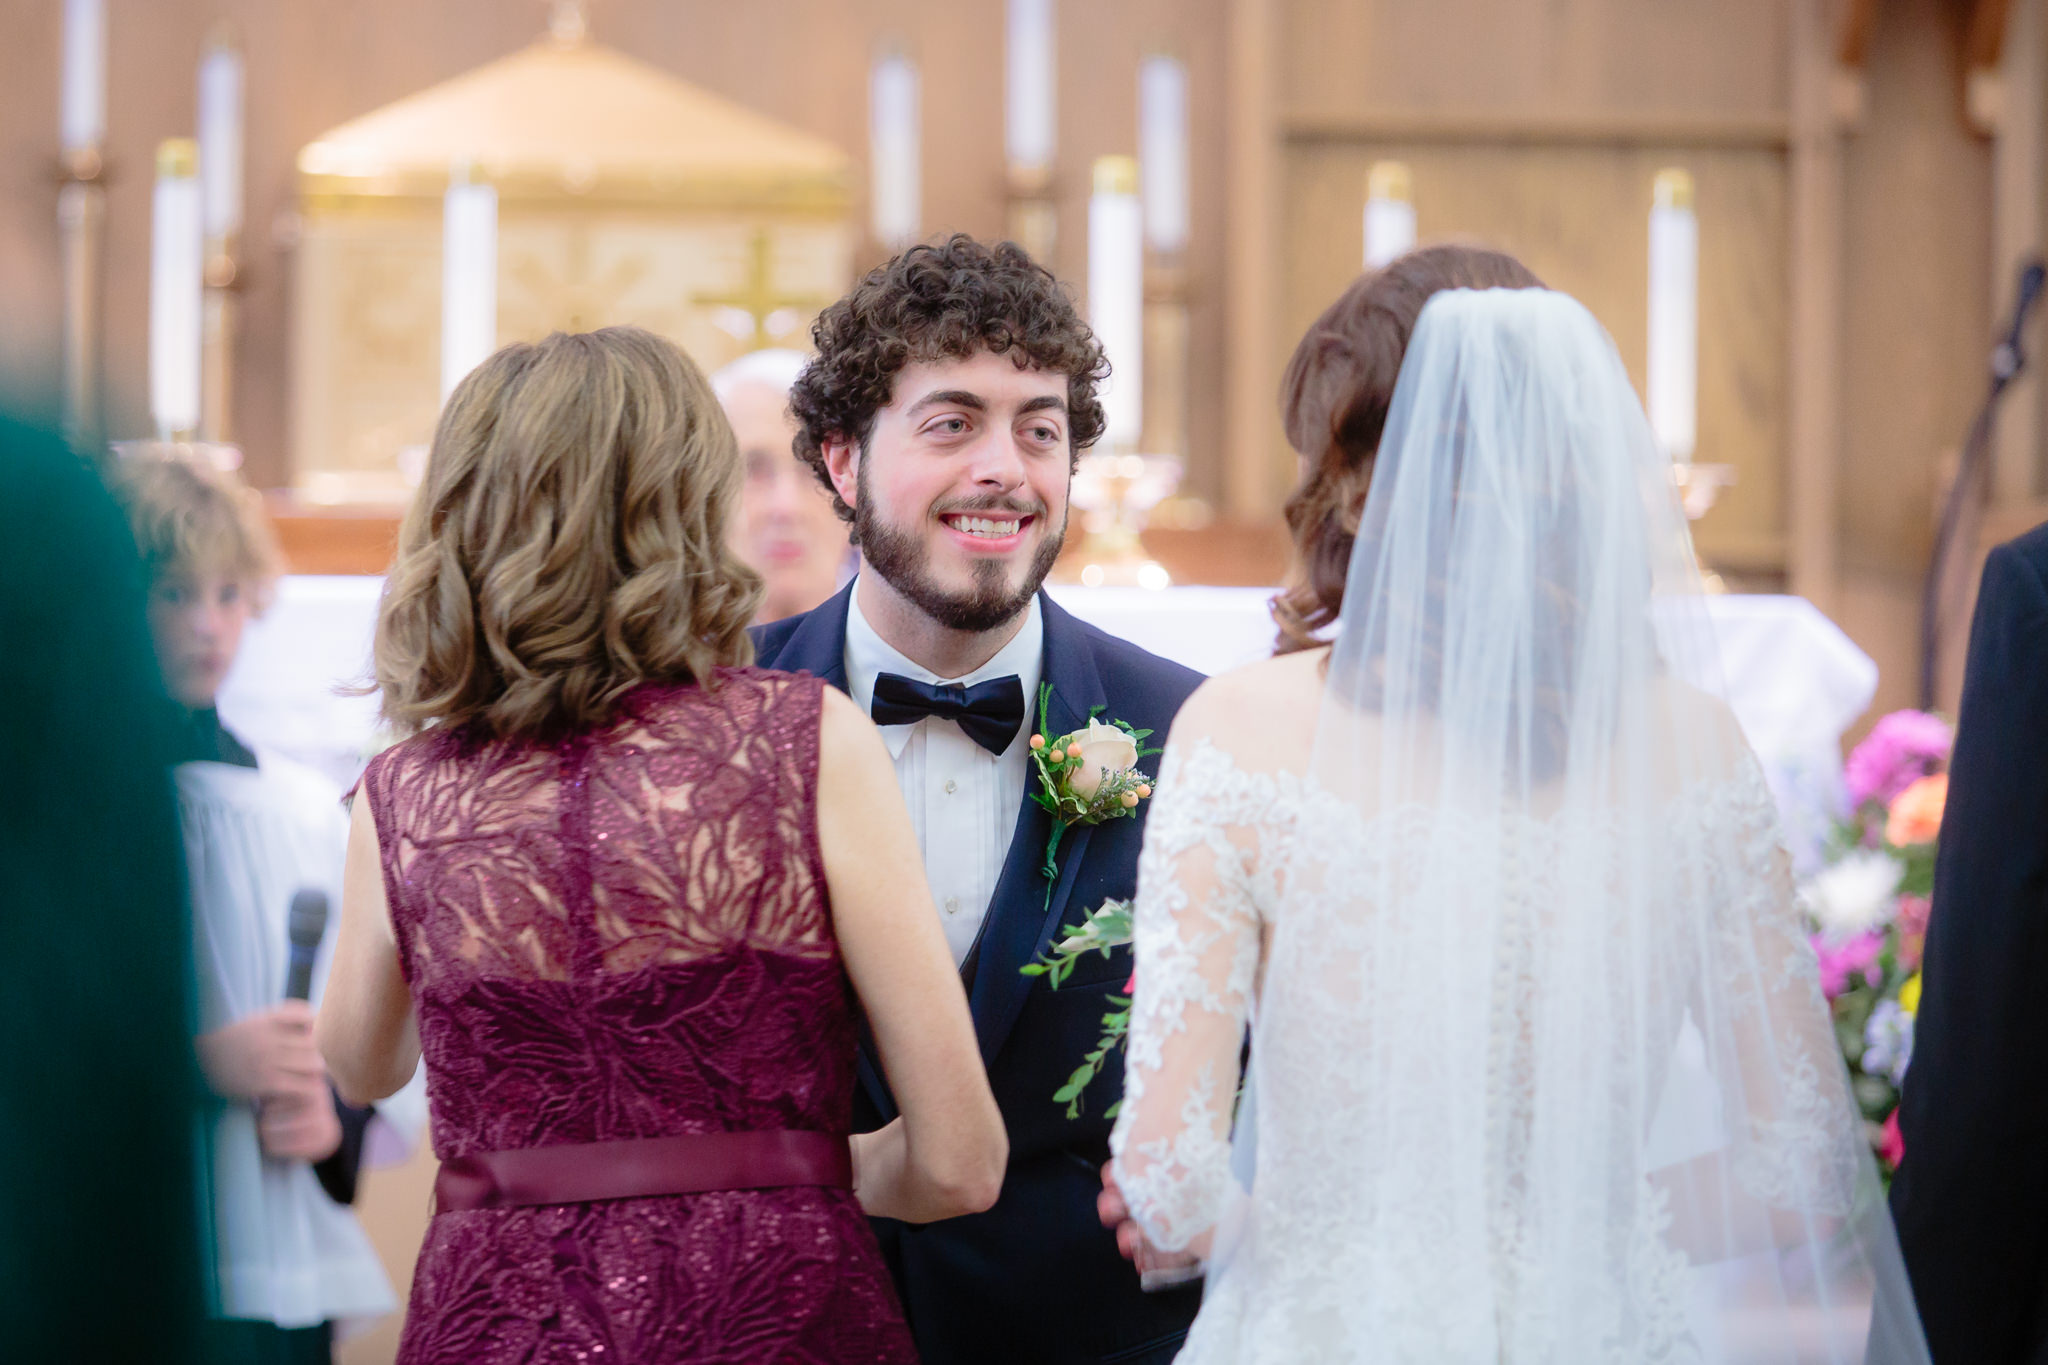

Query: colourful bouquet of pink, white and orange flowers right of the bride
[1798,710,1954,1177]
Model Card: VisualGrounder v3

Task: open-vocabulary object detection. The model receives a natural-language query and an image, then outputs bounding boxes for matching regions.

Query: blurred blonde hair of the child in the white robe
[106,446,285,614]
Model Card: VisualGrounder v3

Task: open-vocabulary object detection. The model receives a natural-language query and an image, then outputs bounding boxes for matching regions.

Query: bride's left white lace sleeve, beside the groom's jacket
[1110,739,1274,1250]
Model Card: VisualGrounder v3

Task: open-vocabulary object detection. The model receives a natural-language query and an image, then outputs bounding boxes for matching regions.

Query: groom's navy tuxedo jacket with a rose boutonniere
[754,585,1202,1365]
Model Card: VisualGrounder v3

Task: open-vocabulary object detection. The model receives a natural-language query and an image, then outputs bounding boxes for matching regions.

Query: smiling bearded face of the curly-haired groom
[825,352,1073,630]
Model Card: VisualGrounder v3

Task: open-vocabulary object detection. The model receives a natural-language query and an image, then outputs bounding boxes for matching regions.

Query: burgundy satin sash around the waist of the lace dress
[434,1132,854,1214]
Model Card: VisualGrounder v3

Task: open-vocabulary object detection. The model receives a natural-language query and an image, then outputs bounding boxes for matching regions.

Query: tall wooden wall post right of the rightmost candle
[1786,0,1860,612]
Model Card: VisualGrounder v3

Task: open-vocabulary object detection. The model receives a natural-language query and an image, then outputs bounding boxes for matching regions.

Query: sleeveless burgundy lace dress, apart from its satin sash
[365,669,915,1365]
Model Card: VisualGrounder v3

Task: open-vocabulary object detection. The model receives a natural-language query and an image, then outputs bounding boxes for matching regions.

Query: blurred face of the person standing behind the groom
[725,381,846,622]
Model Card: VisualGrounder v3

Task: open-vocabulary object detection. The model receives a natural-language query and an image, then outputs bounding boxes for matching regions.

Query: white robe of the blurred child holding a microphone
[176,753,420,1328]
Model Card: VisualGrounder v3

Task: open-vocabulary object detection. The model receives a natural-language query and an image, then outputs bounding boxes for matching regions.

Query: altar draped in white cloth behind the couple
[221,575,1878,853]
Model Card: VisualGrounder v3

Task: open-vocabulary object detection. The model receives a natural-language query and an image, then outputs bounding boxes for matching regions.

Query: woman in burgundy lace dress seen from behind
[317,327,1006,1365]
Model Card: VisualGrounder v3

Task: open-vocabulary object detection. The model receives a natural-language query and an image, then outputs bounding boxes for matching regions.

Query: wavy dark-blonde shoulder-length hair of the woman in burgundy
[375,327,762,741]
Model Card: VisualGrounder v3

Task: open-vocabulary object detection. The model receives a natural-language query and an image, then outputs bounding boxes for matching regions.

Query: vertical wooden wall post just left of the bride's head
[1223,0,1284,518]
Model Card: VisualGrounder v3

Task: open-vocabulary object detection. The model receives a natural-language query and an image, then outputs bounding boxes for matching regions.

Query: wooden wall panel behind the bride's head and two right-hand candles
[1280,137,1788,575]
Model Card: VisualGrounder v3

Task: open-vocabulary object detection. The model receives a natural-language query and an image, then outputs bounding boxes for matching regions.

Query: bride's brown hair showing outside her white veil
[1272,244,1542,655]
